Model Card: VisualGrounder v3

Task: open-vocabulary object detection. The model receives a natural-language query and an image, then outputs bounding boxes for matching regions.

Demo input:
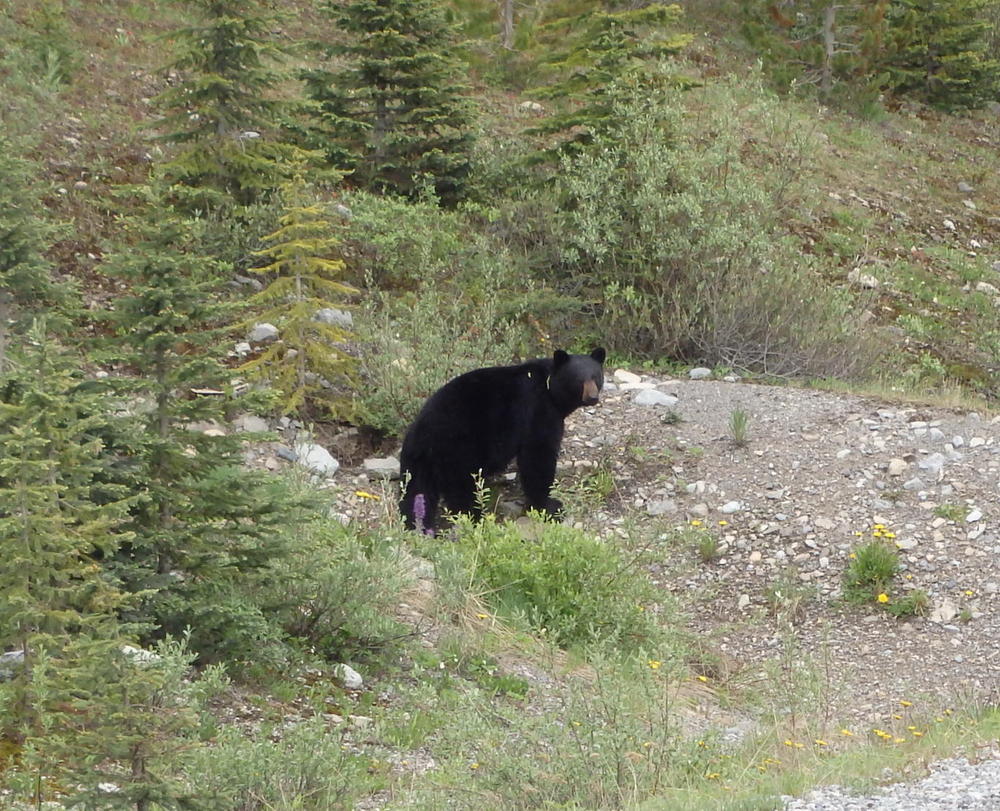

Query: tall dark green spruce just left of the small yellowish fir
[107,191,292,655]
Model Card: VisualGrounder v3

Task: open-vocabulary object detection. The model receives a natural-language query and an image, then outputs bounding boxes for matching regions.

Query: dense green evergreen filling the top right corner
[886,0,1000,110]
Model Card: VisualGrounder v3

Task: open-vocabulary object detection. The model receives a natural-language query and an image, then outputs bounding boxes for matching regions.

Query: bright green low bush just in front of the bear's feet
[440,516,660,652]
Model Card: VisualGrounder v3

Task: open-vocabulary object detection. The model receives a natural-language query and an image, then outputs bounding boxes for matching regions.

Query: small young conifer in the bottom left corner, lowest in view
[13,638,225,811]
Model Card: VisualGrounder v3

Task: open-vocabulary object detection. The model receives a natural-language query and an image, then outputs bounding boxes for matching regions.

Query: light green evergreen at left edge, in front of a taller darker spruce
[0,323,128,731]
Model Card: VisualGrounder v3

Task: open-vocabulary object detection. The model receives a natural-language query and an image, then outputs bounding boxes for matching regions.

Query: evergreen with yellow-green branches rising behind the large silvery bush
[528,3,691,161]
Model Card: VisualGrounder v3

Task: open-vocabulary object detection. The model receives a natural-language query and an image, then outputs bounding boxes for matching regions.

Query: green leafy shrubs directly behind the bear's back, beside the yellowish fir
[344,194,534,434]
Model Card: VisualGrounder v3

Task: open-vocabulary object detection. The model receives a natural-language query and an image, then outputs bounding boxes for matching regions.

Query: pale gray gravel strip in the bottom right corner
[785,758,1000,811]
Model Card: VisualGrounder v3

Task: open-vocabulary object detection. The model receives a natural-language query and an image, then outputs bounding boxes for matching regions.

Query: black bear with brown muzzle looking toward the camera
[399,349,605,532]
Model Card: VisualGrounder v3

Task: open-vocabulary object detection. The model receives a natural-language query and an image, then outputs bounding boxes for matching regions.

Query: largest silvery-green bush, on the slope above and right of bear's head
[557,77,874,375]
